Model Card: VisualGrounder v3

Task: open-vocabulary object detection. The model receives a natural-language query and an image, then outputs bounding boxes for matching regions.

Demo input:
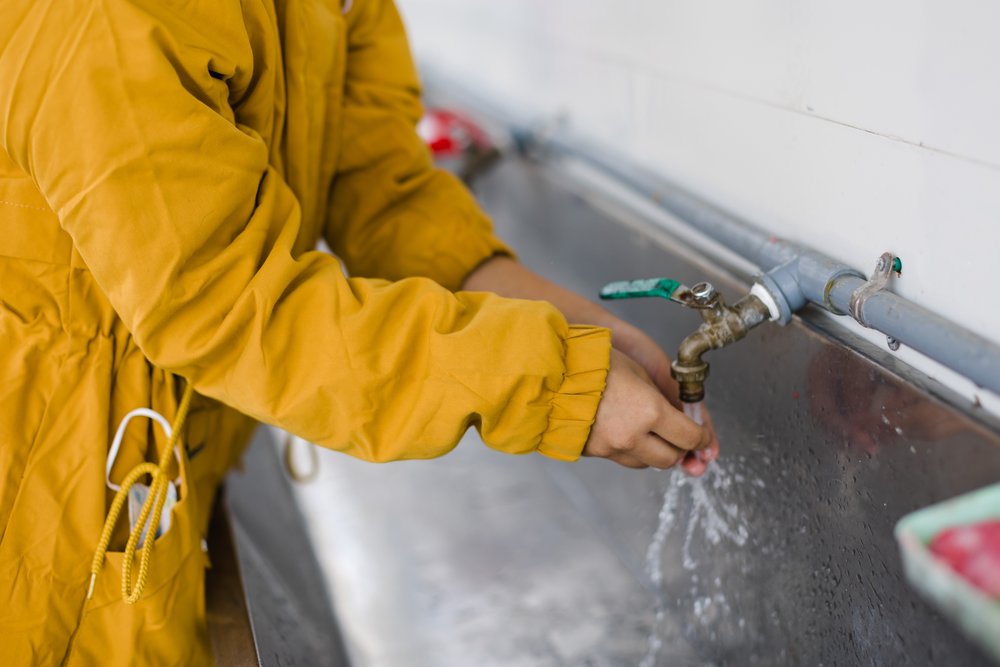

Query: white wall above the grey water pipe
[398,0,1000,409]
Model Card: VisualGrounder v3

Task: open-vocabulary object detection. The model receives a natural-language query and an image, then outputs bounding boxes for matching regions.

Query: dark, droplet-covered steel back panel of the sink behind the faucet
[481,154,1000,665]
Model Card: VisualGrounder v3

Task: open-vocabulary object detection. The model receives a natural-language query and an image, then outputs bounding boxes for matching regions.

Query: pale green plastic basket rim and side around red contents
[895,484,1000,662]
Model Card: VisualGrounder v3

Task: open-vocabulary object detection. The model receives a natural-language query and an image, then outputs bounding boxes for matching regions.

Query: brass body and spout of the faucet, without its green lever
[670,283,770,403]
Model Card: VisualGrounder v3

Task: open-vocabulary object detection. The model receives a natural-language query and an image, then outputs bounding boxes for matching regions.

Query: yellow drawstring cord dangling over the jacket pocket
[87,384,194,604]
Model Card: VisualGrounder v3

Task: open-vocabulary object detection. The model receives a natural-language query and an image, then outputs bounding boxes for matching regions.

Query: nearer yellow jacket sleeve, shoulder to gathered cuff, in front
[0,0,610,461]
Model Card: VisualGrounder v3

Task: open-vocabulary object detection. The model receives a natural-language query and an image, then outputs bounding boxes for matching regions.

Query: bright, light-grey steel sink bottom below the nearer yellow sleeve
[297,434,651,667]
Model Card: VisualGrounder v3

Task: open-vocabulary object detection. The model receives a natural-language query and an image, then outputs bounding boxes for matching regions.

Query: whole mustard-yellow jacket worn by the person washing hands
[0,0,610,665]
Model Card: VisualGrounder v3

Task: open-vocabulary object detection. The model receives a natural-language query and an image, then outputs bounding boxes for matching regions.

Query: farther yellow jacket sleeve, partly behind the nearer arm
[326,0,512,289]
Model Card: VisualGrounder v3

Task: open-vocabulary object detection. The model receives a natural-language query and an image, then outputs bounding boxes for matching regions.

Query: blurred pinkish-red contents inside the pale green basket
[930,520,1000,599]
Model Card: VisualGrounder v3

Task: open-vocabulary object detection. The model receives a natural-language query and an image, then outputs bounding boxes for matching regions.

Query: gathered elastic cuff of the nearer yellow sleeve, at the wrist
[538,325,611,461]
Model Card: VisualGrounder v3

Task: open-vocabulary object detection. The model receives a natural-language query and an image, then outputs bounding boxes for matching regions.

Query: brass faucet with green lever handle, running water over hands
[601,278,776,403]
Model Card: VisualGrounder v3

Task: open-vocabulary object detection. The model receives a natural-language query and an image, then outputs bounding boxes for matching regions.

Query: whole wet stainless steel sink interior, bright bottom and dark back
[286,155,1000,667]
